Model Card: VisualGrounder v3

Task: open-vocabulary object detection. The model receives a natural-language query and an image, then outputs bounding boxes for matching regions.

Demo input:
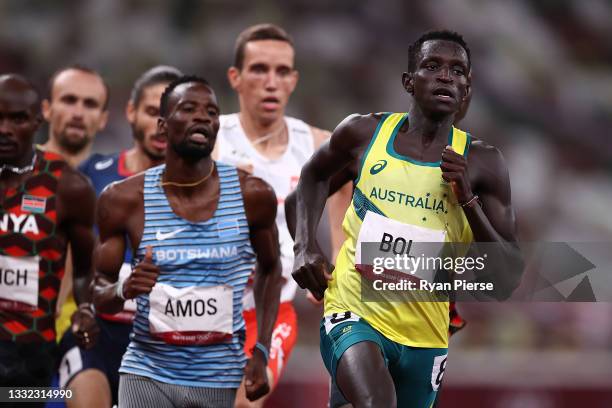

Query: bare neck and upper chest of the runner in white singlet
[238,111,289,158]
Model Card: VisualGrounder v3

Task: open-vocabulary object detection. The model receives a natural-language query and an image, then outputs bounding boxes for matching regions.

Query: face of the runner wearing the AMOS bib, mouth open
[158,82,219,159]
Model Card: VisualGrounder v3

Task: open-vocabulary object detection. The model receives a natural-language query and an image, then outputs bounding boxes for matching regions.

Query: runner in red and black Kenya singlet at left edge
[0,75,97,402]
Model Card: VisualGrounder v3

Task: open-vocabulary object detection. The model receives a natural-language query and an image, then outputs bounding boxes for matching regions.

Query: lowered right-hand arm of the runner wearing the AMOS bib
[241,172,282,401]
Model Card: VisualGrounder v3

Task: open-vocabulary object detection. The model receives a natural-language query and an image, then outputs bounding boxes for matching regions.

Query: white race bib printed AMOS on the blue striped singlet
[149,283,234,345]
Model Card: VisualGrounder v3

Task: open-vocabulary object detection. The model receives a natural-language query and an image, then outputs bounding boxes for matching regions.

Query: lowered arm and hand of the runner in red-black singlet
[57,167,99,348]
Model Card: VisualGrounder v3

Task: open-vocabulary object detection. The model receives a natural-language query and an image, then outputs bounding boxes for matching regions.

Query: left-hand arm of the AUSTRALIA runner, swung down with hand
[293,115,372,300]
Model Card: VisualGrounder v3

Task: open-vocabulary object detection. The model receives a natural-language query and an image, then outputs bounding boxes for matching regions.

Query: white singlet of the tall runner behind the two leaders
[217,113,315,310]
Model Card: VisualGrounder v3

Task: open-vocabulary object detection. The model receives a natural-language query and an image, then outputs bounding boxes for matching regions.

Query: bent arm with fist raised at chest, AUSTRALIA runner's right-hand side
[441,140,524,299]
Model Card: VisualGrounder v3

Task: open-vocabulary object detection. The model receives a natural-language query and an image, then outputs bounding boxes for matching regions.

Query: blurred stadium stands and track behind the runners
[0,0,612,408]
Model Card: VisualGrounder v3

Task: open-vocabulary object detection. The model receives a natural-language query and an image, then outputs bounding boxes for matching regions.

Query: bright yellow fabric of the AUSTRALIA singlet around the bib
[325,113,473,348]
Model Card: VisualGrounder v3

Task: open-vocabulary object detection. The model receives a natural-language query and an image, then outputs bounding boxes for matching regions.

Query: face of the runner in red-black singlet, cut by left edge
[0,76,41,165]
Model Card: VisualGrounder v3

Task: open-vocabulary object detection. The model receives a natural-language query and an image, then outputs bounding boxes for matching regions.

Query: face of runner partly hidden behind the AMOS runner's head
[126,83,168,160]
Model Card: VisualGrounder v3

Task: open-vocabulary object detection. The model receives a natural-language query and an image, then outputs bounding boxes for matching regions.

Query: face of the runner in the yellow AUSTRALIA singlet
[404,40,470,115]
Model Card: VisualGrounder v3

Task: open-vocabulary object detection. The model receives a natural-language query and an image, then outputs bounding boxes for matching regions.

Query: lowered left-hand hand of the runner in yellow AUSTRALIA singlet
[291,247,334,300]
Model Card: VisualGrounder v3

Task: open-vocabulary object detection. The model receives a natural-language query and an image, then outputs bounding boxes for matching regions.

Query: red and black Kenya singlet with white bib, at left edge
[0,149,66,342]
